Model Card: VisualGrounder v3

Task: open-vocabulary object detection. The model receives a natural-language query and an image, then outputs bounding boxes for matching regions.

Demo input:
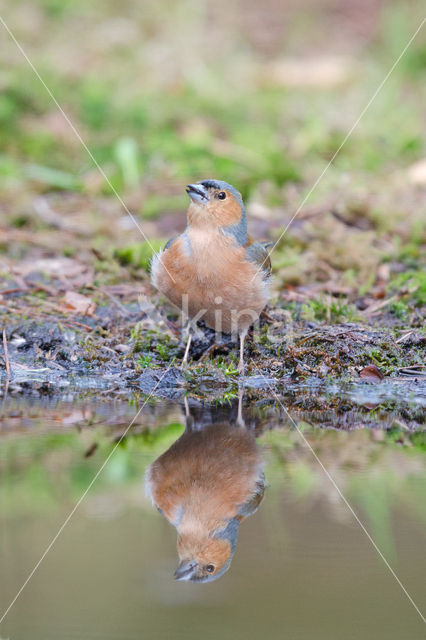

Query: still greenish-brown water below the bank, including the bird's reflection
[0,395,426,640]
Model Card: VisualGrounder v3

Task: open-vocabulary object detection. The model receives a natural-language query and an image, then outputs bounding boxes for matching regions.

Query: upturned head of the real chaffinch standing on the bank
[186,180,245,234]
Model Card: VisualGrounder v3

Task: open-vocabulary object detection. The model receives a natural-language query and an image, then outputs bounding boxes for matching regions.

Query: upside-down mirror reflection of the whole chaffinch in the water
[146,396,265,582]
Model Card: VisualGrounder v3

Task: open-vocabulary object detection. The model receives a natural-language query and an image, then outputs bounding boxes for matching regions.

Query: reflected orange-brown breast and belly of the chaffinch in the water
[148,423,262,537]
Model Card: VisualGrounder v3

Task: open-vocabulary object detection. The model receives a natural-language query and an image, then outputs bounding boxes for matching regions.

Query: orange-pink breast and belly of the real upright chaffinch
[152,227,268,333]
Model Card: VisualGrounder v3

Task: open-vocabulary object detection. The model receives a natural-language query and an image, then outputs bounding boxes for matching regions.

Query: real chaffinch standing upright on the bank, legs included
[151,180,271,374]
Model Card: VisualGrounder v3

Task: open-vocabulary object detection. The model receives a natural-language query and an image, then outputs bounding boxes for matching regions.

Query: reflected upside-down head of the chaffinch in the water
[175,518,239,582]
